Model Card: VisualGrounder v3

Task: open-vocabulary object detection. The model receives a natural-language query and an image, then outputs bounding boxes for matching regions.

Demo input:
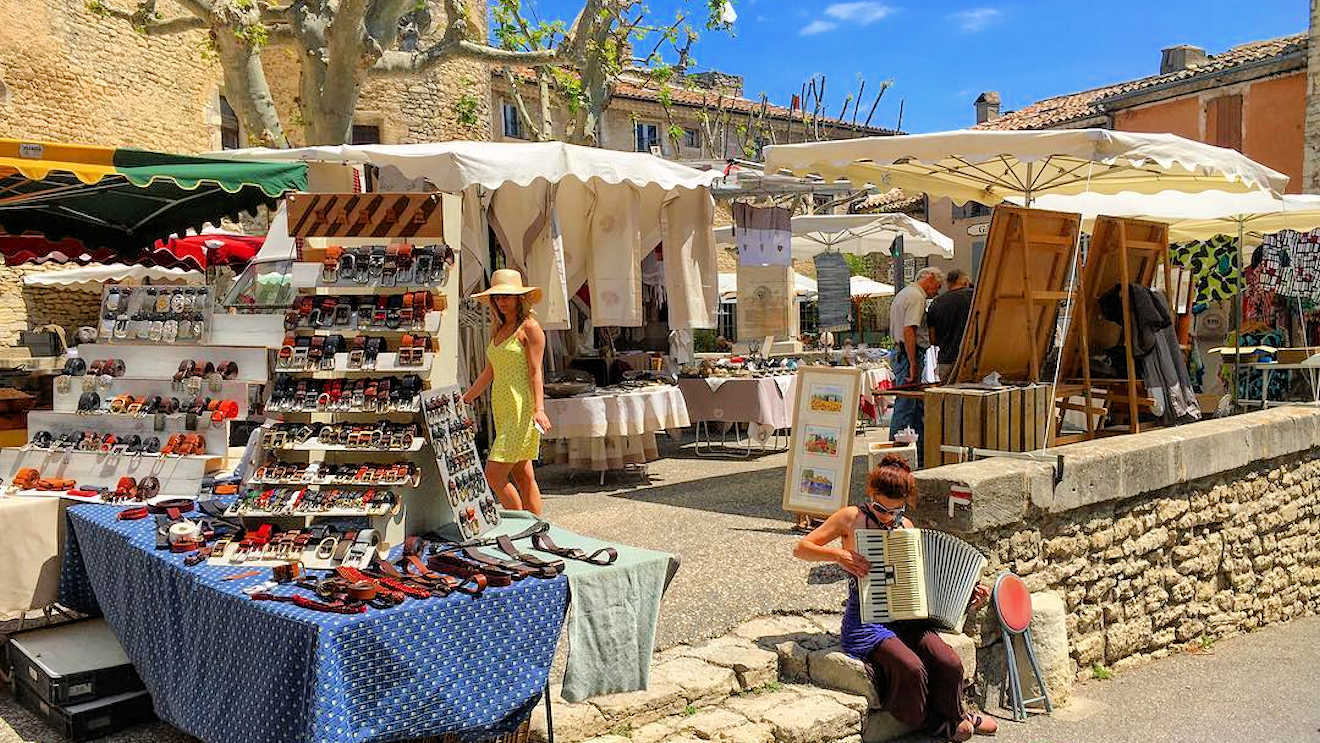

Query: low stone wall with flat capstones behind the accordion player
[917,408,1320,677]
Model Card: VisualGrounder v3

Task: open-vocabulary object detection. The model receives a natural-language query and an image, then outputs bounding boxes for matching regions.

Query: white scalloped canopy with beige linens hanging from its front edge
[223,141,719,330]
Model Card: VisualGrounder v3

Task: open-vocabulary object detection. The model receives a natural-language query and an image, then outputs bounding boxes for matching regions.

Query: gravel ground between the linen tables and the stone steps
[540,437,866,649]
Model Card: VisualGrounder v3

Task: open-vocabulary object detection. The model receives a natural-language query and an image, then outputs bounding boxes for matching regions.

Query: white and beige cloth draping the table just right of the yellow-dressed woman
[541,384,692,471]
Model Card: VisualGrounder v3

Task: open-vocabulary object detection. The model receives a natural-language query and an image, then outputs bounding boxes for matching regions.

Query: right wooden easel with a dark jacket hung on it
[1052,216,1173,443]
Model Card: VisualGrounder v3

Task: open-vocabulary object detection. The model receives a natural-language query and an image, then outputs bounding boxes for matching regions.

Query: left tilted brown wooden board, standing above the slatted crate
[952,205,1081,383]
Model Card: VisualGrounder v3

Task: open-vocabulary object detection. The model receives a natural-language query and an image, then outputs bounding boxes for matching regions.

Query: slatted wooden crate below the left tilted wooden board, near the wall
[923,384,1053,467]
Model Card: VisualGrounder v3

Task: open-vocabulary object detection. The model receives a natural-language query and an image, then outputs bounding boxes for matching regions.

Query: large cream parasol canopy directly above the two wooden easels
[766,129,1288,206]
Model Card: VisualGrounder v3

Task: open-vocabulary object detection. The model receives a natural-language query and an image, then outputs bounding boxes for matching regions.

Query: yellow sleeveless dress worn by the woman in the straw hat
[486,331,541,463]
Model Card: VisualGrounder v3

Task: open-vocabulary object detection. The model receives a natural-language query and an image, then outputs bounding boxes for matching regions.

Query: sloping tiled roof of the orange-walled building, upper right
[975,33,1307,129]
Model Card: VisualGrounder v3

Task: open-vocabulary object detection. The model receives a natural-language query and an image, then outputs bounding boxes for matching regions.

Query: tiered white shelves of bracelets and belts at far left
[0,299,269,505]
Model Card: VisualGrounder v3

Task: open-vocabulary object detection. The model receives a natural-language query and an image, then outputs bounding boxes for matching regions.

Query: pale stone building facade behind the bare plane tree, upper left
[0,0,491,346]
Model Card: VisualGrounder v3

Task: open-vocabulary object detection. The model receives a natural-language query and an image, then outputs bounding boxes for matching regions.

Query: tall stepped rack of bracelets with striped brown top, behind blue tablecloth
[211,194,464,559]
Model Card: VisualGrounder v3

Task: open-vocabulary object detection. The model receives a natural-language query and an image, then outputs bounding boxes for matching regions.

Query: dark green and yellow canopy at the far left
[0,140,308,260]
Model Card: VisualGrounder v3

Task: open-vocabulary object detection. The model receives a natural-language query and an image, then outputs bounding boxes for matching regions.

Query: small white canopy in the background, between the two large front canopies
[714,214,953,259]
